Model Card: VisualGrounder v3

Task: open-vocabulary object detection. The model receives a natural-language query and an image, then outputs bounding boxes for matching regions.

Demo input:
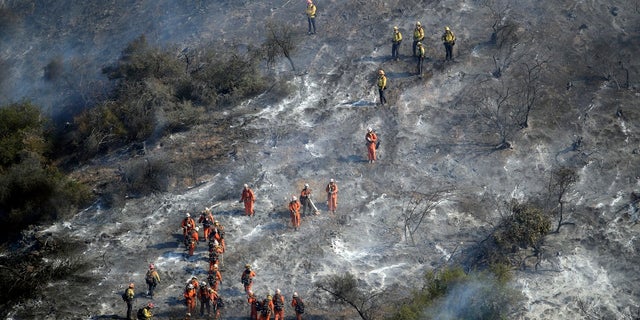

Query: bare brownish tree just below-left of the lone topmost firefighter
[263,21,296,71]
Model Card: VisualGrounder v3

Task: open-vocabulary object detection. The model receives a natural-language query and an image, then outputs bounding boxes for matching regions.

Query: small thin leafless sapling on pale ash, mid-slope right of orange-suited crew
[402,190,450,245]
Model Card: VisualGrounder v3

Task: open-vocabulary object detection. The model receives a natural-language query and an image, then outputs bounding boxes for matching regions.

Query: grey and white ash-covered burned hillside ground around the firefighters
[3,0,640,319]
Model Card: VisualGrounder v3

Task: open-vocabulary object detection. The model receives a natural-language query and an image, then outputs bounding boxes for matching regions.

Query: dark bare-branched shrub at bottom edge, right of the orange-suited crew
[316,273,383,320]
